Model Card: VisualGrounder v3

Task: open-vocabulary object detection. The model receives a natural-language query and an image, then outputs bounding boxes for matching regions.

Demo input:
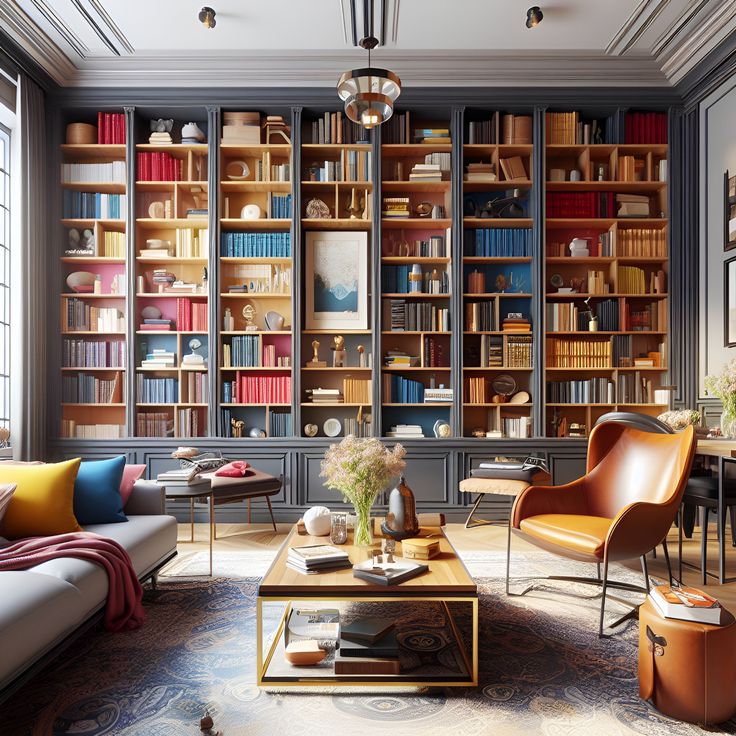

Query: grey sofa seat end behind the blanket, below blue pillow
[84,515,177,576]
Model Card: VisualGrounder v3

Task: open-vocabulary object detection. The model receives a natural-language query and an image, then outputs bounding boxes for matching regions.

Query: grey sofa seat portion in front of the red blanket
[0,570,95,688]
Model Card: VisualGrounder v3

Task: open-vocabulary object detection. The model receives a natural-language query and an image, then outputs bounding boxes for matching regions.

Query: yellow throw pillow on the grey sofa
[0,458,81,539]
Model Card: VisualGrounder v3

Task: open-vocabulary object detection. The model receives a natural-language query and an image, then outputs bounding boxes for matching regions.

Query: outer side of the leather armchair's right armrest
[606,501,677,561]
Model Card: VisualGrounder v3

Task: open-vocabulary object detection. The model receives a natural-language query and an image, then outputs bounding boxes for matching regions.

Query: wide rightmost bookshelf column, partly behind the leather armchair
[545,113,669,437]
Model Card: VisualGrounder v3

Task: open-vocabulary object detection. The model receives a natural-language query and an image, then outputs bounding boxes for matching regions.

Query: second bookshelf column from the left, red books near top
[132,129,210,438]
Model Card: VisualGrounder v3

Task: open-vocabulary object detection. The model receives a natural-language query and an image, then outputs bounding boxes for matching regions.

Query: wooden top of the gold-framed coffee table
[258,527,478,598]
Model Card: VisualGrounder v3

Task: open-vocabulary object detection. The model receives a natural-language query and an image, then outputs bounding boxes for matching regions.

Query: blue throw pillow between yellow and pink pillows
[74,455,128,526]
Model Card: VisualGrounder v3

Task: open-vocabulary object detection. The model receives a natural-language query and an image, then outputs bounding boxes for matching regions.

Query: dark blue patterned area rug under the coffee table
[5,553,736,736]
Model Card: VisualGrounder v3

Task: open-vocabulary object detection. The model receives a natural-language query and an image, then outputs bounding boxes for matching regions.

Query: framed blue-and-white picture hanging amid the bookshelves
[305,232,368,330]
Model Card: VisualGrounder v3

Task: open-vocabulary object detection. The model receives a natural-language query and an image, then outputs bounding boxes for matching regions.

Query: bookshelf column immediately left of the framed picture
[217,111,295,437]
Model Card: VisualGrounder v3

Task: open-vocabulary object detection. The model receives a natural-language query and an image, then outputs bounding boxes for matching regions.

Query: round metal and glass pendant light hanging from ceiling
[337,36,401,129]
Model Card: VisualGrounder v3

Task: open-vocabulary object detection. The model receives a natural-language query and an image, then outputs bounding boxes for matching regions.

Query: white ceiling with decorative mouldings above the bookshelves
[0,0,736,87]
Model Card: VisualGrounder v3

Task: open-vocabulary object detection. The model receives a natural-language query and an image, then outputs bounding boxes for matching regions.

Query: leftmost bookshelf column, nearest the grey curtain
[59,112,128,439]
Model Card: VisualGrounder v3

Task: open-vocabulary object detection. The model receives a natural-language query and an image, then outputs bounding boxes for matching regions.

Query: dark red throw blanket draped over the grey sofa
[0,532,145,631]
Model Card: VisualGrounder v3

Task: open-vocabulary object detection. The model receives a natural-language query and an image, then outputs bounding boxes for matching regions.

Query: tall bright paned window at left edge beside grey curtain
[0,125,10,428]
